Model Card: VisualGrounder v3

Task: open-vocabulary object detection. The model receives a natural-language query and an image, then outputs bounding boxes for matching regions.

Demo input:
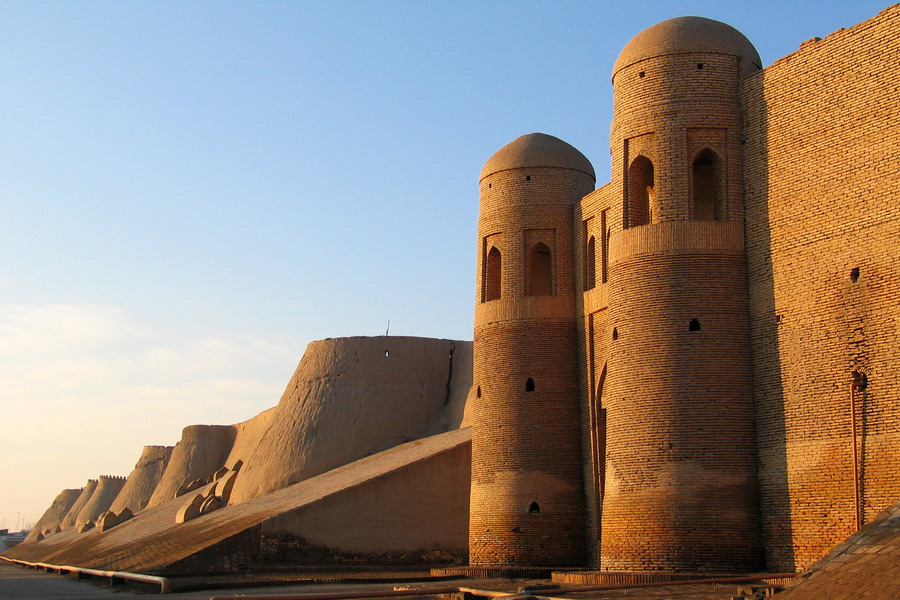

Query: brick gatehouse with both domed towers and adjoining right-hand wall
[470,6,900,572]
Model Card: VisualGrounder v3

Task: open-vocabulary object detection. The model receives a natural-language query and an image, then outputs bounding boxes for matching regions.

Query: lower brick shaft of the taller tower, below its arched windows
[601,221,761,572]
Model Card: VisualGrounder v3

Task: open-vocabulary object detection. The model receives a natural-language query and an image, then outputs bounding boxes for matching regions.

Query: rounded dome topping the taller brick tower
[613,17,762,77]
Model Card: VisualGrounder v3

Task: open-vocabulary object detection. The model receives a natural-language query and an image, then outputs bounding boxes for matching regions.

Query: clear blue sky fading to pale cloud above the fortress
[0,0,887,529]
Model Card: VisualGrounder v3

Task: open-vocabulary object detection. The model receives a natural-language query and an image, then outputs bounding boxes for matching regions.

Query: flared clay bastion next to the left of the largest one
[147,425,236,507]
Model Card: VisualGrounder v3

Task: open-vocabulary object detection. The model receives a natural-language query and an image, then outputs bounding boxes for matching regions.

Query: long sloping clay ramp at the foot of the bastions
[4,428,472,572]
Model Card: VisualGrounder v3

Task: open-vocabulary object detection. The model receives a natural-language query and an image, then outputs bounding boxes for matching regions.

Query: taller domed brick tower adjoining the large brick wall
[600,17,761,572]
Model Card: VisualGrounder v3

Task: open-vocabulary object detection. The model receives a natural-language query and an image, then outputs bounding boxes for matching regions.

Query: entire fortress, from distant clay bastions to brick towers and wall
[15,5,900,577]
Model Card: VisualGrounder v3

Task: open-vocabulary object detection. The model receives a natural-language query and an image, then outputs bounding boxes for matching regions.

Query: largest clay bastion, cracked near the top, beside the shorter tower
[226,337,471,504]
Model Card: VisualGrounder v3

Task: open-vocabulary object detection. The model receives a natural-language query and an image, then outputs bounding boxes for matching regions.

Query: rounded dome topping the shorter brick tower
[481,133,596,179]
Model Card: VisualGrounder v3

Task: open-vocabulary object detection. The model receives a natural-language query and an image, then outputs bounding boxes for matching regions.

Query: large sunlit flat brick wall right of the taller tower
[743,5,900,570]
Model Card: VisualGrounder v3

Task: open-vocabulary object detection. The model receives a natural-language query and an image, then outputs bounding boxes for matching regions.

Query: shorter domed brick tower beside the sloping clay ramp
[469,133,595,566]
